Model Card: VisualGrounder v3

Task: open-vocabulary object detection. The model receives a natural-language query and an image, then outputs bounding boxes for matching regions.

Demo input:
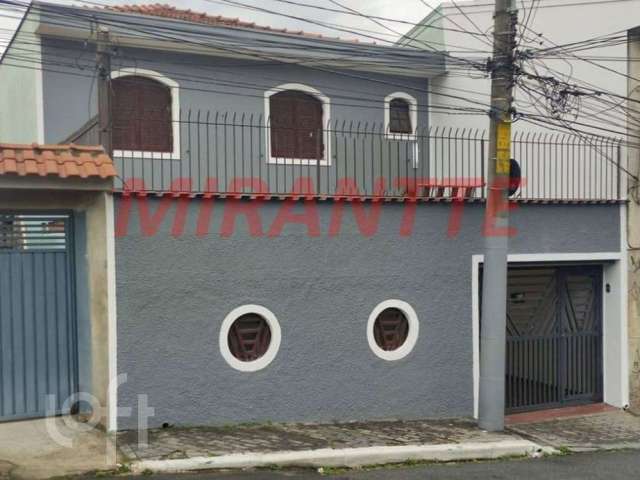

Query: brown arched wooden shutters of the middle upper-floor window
[269,90,324,160]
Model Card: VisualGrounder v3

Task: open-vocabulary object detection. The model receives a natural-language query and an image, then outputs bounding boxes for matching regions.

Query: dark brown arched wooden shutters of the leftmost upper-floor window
[111,75,173,152]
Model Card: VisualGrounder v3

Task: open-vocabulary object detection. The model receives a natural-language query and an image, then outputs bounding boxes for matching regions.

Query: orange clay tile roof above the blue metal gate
[0,143,116,179]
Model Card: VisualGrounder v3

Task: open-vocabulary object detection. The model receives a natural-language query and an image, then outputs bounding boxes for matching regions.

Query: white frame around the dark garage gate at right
[471,252,629,418]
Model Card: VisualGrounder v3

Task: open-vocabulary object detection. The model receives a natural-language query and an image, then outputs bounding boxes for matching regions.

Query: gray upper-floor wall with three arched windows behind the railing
[37,38,429,197]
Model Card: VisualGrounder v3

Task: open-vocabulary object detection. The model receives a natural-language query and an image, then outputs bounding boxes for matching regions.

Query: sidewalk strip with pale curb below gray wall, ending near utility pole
[118,419,541,473]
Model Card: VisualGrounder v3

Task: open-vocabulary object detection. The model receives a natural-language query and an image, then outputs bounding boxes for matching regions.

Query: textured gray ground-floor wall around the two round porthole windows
[116,199,619,428]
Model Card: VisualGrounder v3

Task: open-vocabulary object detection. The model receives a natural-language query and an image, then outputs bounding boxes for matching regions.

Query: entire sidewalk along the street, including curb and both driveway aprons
[5,406,640,480]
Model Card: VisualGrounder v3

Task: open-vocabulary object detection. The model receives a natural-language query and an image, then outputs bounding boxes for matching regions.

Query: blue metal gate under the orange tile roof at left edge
[0,213,78,421]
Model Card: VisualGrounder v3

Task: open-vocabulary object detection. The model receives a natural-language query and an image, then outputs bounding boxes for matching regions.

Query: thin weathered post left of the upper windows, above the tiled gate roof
[96,26,113,157]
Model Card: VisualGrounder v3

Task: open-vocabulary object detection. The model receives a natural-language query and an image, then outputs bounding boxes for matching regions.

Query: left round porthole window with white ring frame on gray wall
[220,305,281,372]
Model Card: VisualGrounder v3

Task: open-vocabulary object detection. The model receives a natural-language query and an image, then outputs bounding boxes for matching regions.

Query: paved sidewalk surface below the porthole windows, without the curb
[118,419,513,460]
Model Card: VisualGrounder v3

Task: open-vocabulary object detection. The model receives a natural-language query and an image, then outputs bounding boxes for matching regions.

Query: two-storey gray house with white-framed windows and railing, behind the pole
[0,2,627,428]
